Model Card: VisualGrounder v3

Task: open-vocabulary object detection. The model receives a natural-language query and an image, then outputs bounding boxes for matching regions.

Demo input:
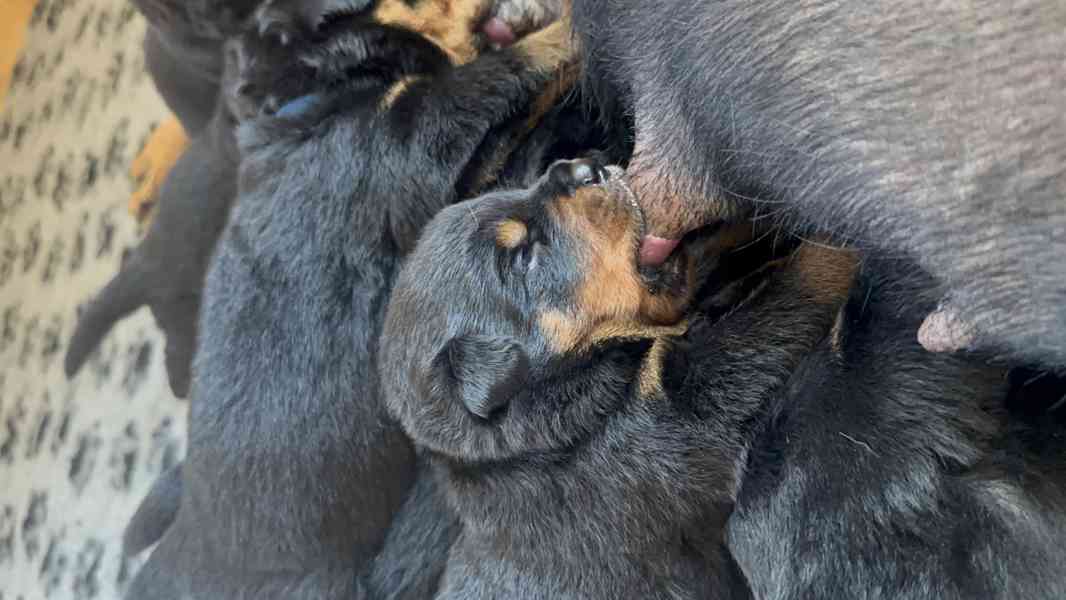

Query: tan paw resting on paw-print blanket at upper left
[127,115,189,228]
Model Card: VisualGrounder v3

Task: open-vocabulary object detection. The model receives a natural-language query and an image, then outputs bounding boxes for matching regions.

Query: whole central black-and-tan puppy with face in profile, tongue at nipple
[379,161,855,600]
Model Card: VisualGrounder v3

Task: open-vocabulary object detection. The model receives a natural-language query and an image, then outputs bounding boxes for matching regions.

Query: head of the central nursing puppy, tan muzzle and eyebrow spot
[381,161,692,460]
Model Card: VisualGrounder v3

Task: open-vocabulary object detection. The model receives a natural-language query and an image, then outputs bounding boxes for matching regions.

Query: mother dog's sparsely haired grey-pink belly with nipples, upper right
[575,0,1066,369]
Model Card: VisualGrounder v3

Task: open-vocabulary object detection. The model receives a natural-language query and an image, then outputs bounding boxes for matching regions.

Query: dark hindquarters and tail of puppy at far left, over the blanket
[64,36,255,398]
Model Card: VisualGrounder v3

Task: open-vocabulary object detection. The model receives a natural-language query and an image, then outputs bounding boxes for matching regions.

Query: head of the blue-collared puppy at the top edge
[226,0,568,120]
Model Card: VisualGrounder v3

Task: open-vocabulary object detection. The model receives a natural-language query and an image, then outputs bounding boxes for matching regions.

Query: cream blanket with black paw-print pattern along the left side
[0,0,185,600]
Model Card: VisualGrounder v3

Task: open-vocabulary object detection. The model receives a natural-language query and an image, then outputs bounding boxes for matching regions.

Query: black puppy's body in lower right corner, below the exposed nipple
[728,263,1066,599]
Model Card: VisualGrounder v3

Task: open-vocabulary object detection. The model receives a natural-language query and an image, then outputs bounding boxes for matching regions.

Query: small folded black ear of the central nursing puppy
[433,336,530,419]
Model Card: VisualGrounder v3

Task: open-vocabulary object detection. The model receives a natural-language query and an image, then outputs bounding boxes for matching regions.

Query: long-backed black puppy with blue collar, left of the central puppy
[122,0,574,600]
